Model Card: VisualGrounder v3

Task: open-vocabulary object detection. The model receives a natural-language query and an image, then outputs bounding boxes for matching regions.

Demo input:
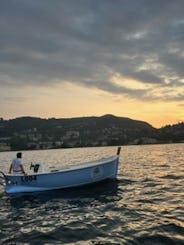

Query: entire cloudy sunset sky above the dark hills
[0,0,184,127]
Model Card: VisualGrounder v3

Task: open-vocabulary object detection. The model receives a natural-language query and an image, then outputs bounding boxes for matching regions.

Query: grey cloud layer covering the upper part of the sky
[0,0,184,101]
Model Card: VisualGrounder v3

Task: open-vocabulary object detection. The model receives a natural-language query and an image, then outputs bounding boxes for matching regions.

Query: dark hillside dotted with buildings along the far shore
[0,115,184,150]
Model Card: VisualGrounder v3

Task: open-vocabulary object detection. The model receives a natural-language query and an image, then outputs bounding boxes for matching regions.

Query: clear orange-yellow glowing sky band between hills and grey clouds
[1,84,184,128]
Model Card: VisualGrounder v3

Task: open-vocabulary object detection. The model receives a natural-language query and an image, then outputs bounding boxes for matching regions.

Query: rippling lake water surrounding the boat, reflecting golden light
[0,144,184,245]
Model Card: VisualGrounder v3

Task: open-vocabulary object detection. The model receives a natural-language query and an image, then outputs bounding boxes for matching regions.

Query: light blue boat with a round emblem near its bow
[0,147,121,194]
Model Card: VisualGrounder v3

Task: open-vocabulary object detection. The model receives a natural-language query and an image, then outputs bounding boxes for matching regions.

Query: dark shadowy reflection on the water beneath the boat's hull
[8,180,118,209]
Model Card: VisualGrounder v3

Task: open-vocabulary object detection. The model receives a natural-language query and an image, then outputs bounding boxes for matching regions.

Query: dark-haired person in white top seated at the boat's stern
[9,152,26,175]
